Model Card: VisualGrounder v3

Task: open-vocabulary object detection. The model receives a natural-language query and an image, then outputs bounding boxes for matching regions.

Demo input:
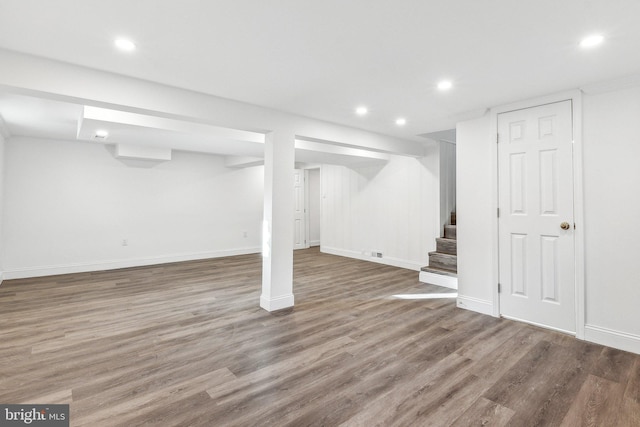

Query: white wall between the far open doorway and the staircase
[320,150,439,270]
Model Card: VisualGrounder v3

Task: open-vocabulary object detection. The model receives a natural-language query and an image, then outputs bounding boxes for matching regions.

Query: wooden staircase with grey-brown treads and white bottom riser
[420,212,458,289]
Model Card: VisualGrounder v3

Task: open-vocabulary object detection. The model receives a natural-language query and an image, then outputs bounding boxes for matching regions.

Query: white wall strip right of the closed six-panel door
[583,88,640,344]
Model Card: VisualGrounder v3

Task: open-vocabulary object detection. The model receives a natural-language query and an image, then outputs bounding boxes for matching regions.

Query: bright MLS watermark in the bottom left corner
[0,404,69,427]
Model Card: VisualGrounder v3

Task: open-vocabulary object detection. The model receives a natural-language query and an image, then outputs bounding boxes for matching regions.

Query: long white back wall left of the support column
[3,137,264,278]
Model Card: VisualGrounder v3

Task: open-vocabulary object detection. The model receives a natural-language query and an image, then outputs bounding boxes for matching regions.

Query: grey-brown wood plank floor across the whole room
[0,248,640,426]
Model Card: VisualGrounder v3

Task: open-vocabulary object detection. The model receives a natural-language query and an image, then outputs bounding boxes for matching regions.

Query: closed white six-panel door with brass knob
[498,101,576,333]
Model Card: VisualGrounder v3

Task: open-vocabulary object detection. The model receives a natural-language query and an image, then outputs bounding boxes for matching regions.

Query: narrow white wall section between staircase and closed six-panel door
[456,114,496,314]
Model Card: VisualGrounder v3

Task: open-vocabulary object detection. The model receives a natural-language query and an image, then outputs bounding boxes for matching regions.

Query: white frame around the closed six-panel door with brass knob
[490,90,586,339]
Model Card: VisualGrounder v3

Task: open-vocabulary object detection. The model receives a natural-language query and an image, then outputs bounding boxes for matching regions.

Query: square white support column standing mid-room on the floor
[260,131,295,311]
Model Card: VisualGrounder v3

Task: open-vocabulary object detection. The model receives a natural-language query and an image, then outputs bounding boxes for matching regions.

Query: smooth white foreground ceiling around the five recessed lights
[0,0,640,140]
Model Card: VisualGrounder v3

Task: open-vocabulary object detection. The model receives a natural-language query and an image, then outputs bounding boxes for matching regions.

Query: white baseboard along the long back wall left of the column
[3,248,260,280]
